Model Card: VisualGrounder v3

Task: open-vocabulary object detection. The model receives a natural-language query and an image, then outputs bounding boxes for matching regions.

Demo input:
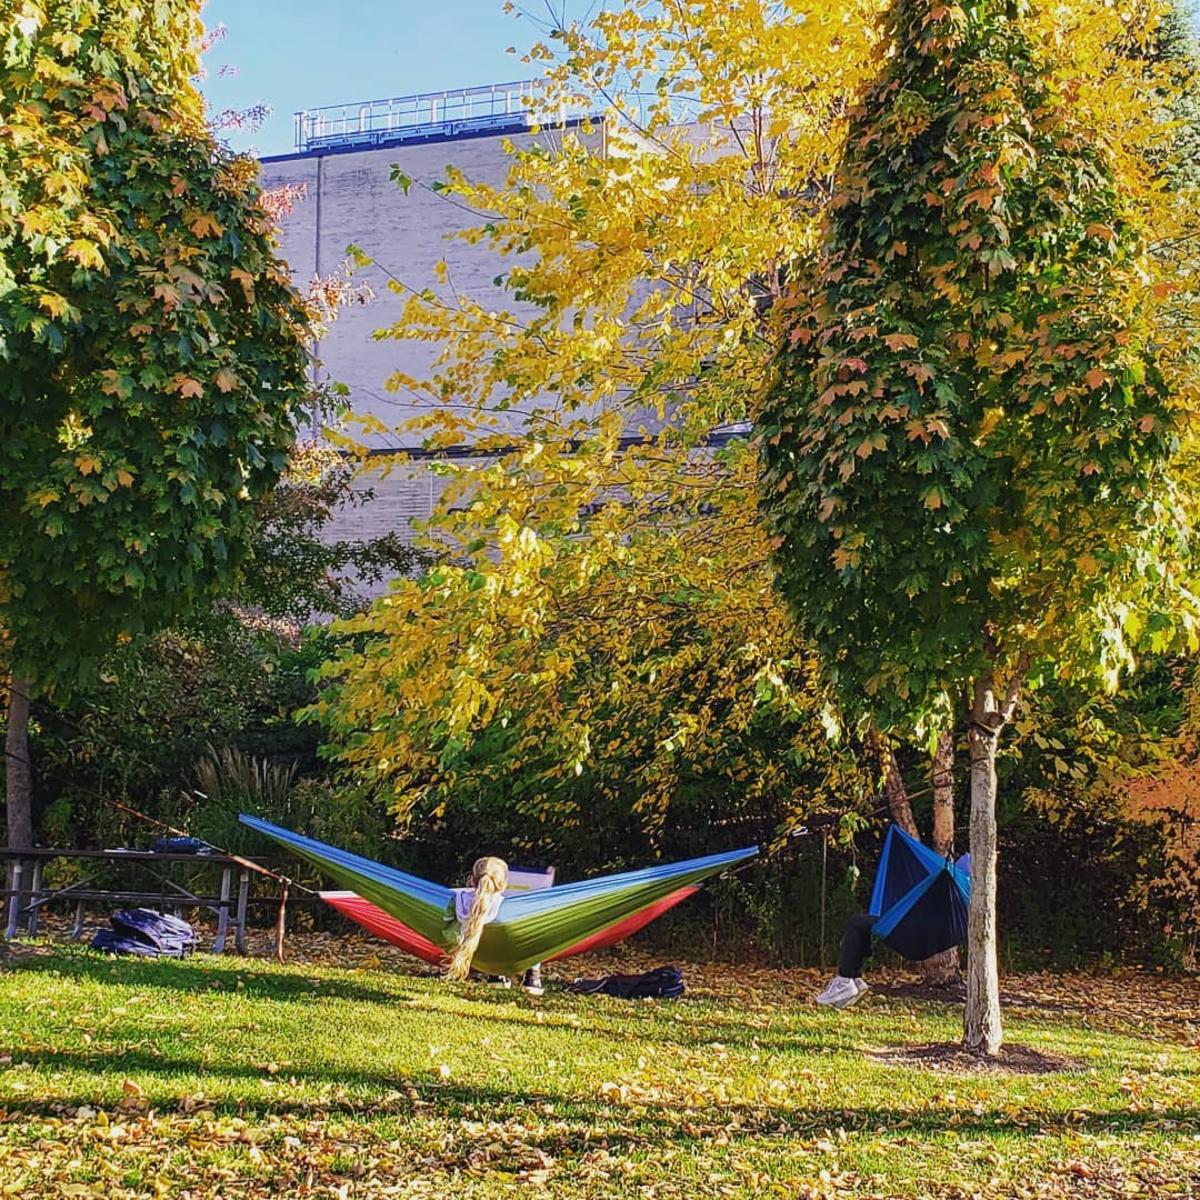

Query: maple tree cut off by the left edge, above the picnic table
[0,0,311,846]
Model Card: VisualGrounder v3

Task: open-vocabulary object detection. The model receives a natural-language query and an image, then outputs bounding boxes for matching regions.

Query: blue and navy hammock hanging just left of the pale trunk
[870,826,971,960]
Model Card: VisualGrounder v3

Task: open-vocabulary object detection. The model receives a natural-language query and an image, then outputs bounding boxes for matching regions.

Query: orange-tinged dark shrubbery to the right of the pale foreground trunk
[998,658,1200,966]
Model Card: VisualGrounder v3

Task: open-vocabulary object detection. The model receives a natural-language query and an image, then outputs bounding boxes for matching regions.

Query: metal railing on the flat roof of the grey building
[294,79,587,154]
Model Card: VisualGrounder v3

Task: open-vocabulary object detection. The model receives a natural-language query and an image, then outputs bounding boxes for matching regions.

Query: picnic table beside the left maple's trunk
[0,847,288,954]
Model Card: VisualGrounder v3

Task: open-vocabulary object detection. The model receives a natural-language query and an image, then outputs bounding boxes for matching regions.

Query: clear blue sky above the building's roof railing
[203,0,544,155]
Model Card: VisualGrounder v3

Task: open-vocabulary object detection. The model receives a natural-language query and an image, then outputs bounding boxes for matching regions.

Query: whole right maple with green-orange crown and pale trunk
[761,0,1200,1054]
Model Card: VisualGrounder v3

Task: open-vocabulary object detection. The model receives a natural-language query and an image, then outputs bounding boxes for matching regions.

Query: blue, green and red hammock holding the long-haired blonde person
[241,814,758,974]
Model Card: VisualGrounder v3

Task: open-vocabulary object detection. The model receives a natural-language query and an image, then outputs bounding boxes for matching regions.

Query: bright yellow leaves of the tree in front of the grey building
[314,0,1192,814]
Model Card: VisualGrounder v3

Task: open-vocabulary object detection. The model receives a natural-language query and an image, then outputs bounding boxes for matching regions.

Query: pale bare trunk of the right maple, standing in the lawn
[962,715,1004,1055]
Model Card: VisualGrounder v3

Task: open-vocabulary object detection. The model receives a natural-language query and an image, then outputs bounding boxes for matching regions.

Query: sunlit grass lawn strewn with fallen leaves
[0,938,1200,1200]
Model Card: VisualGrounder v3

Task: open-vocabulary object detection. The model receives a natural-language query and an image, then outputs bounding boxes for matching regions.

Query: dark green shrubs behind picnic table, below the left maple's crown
[31,612,390,874]
